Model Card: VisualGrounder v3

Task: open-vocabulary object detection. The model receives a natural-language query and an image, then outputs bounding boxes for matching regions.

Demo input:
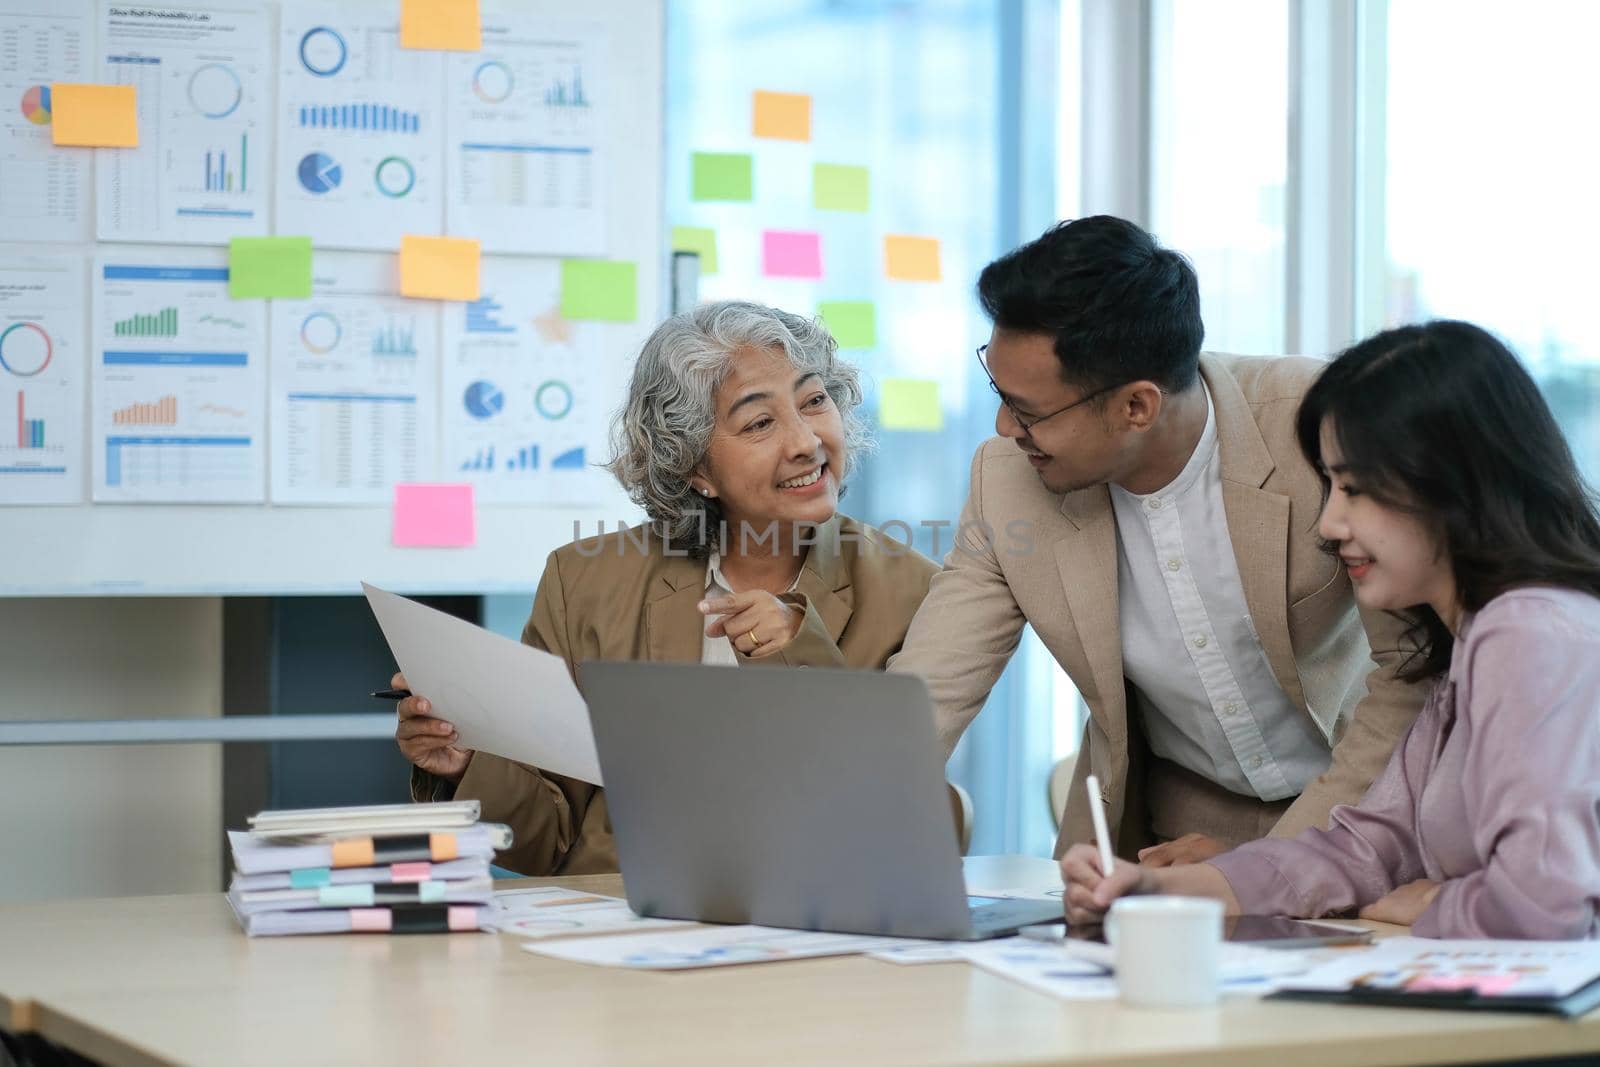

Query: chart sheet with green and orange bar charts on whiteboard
[91,246,267,504]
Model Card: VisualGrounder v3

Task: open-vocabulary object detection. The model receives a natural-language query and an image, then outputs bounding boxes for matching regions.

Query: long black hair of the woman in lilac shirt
[1296,322,1600,681]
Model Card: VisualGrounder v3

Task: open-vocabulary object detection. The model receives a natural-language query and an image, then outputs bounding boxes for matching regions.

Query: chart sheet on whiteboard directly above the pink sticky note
[270,253,438,504]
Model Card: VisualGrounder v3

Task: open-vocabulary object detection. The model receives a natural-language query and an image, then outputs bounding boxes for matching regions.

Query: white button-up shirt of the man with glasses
[1110,384,1328,800]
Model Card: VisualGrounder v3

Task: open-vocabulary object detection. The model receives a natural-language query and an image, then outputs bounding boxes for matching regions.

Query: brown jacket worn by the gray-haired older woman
[411,515,938,875]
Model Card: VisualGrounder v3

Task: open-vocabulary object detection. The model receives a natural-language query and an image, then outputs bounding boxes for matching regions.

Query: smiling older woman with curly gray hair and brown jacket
[394,301,938,875]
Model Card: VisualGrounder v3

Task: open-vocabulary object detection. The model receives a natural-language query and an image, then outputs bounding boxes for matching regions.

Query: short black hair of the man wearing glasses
[978,214,1205,392]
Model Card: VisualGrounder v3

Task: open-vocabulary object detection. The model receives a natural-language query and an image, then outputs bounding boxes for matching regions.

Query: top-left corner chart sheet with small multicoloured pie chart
[0,0,94,242]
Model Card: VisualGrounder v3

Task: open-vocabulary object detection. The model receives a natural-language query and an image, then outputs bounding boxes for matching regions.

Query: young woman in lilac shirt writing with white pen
[1061,322,1600,939]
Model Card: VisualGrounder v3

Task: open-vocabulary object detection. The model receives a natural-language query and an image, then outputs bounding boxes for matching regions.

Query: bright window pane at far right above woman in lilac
[1381,0,1600,485]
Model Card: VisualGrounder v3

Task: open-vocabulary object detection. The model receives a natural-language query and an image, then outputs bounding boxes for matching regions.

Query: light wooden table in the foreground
[0,857,1600,1067]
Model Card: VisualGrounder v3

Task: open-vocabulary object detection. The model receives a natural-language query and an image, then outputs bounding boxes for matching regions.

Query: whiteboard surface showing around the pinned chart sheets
[0,0,667,597]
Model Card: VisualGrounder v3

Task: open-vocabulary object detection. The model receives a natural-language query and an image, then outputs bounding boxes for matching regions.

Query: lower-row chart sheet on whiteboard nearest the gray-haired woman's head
[440,256,622,506]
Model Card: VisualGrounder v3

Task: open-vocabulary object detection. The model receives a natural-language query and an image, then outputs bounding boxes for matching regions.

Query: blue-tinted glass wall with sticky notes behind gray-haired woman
[666,0,1075,853]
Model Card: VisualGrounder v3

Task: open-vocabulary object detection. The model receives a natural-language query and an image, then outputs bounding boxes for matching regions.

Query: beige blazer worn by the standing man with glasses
[890,355,1426,856]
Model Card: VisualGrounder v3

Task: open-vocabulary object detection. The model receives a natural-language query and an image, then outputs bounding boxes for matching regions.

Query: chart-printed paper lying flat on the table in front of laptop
[523,926,899,971]
